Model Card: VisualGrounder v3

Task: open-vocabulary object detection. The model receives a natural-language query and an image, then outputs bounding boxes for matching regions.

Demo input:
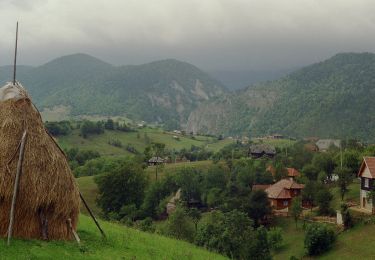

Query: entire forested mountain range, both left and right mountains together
[0,53,375,141]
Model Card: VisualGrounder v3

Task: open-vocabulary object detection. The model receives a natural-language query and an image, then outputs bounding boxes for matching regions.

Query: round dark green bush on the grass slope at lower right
[304,224,336,255]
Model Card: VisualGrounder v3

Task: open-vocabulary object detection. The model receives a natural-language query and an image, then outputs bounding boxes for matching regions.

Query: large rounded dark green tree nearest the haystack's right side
[95,159,147,217]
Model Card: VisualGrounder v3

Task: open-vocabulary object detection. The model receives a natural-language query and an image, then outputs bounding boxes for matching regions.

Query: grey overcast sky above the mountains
[0,0,375,70]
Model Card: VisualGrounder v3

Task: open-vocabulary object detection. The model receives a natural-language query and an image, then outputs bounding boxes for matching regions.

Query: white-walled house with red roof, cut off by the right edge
[358,157,375,213]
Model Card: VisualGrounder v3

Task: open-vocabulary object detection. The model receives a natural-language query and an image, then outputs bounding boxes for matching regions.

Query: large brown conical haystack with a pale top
[0,83,79,239]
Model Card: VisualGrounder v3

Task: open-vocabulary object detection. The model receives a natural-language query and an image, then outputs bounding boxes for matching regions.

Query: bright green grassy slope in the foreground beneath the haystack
[0,215,225,259]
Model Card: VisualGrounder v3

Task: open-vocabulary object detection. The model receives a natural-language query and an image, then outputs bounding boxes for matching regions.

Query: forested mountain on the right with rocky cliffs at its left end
[187,53,375,141]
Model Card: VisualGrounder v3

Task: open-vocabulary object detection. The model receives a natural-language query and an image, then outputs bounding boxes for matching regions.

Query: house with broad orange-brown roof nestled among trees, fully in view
[265,179,304,210]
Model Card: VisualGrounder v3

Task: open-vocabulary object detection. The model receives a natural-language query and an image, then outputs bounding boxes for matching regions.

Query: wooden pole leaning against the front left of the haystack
[8,131,27,246]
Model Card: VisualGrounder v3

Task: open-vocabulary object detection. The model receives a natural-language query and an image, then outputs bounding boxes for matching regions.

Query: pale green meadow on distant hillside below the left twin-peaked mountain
[58,128,221,156]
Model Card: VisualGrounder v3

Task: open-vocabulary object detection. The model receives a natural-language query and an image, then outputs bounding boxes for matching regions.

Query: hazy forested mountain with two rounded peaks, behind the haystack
[0,54,226,128]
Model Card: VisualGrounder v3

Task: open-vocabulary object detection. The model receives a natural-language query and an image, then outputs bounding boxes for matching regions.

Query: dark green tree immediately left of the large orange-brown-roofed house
[247,190,272,227]
